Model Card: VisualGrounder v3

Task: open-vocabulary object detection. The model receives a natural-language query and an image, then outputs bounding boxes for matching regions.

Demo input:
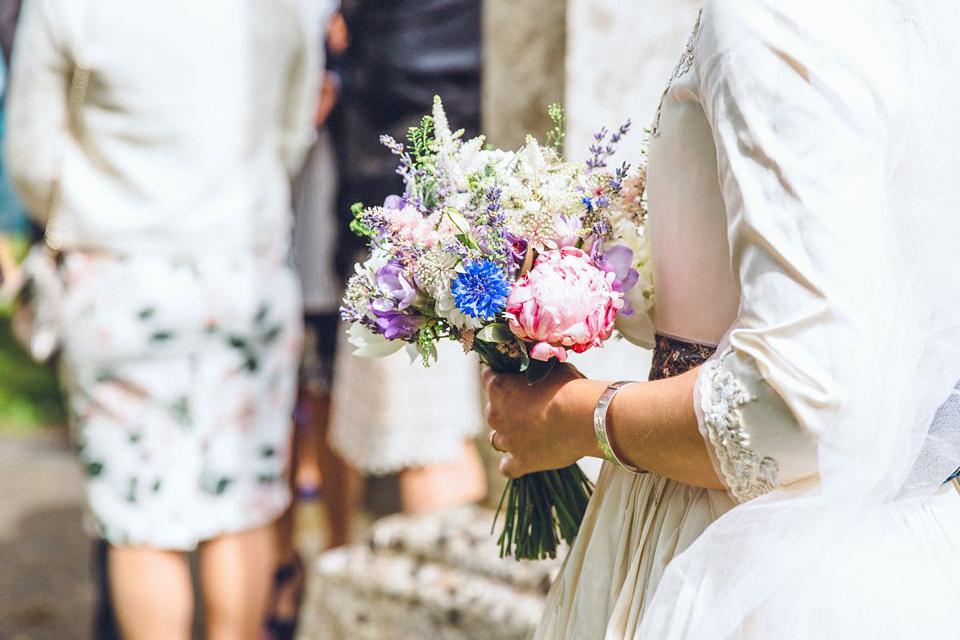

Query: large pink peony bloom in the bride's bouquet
[504,247,623,362]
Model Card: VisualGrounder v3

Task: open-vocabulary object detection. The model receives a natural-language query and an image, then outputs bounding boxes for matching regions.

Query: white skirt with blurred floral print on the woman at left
[61,248,302,550]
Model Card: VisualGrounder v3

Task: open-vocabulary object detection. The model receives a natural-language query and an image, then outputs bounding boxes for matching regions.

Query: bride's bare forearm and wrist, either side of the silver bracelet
[557,369,724,489]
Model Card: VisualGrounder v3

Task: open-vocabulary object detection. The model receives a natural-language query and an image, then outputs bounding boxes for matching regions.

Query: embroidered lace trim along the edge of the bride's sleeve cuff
[700,358,780,502]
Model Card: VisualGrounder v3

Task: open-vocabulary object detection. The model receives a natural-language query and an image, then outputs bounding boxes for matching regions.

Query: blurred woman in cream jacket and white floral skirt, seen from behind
[5,0,316,640]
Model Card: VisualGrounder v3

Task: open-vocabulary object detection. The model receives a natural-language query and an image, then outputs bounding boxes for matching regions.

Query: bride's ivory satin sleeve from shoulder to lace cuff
[695,0,884,502]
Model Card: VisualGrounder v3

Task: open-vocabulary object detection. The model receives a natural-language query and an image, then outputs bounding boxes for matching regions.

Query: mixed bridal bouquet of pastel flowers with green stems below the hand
[341,99,652,559]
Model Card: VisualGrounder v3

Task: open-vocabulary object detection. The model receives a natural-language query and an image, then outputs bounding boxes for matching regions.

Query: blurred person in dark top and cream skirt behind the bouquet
[330,0,486,512]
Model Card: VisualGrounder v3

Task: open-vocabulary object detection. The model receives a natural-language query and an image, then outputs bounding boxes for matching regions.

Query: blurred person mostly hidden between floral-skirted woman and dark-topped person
[263,5,359,640]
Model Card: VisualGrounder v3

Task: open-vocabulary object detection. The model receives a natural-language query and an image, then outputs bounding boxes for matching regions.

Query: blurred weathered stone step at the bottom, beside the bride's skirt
[300,507,561,640]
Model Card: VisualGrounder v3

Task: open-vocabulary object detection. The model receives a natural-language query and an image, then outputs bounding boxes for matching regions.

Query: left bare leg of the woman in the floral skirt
[107,547,193,640]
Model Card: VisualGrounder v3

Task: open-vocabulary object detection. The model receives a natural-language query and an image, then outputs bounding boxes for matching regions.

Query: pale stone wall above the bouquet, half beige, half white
[483,0,702,159]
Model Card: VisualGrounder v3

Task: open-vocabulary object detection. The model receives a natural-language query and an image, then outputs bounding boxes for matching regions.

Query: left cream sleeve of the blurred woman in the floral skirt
[4,0,74,224]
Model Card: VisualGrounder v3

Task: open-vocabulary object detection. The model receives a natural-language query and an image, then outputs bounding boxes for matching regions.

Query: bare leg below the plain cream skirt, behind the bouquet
[400,440,487,513]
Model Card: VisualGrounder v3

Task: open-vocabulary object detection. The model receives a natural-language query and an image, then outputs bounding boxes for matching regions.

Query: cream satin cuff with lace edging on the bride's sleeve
[695,349,817,502]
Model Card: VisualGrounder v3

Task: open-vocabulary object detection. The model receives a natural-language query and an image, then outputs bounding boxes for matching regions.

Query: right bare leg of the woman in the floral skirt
[200,525,275,640]
